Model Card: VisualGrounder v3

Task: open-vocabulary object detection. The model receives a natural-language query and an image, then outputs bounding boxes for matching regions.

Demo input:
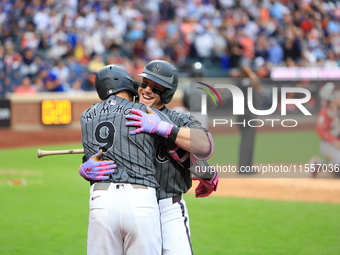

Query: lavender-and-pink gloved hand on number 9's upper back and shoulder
[125,107,174,138]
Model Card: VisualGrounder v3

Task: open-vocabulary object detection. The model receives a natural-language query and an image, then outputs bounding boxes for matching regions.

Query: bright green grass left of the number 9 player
[0,145,89,255]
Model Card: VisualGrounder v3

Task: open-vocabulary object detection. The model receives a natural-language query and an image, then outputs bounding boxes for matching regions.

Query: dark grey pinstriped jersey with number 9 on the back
[80,96,171,188]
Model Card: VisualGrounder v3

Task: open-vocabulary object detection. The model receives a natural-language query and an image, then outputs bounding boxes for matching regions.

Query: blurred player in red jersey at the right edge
[309,83,340,177]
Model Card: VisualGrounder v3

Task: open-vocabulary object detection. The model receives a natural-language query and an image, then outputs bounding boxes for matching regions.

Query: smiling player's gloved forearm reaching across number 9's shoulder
[125,107,214,156]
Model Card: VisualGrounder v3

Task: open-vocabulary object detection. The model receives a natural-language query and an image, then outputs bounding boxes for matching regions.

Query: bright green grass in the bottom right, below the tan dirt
[186,195,340,255]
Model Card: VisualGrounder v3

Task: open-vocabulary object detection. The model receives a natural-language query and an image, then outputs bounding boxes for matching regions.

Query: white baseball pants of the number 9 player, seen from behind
[87,183,162,255]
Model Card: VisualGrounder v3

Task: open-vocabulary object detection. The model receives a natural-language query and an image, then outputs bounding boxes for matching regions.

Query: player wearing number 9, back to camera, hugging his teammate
[80,65,178,255]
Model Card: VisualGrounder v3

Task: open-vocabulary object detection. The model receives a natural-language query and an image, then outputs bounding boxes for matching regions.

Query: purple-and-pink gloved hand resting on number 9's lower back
[79,150,116,181]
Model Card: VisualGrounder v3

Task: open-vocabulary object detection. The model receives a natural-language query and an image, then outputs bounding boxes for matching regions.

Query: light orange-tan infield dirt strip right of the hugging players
[189,178,340,203]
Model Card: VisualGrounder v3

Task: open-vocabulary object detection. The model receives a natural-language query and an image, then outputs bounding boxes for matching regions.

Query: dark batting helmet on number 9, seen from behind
[96,65,138,100]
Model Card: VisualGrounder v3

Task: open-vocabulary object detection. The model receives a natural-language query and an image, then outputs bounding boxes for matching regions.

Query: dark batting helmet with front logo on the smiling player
[138,60,178,104]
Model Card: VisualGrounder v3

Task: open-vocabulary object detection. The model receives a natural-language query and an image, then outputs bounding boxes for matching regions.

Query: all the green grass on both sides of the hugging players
[0,132,334,255]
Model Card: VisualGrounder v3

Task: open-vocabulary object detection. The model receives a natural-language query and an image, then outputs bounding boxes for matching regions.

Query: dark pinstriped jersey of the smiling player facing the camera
[155,107,208,199]
